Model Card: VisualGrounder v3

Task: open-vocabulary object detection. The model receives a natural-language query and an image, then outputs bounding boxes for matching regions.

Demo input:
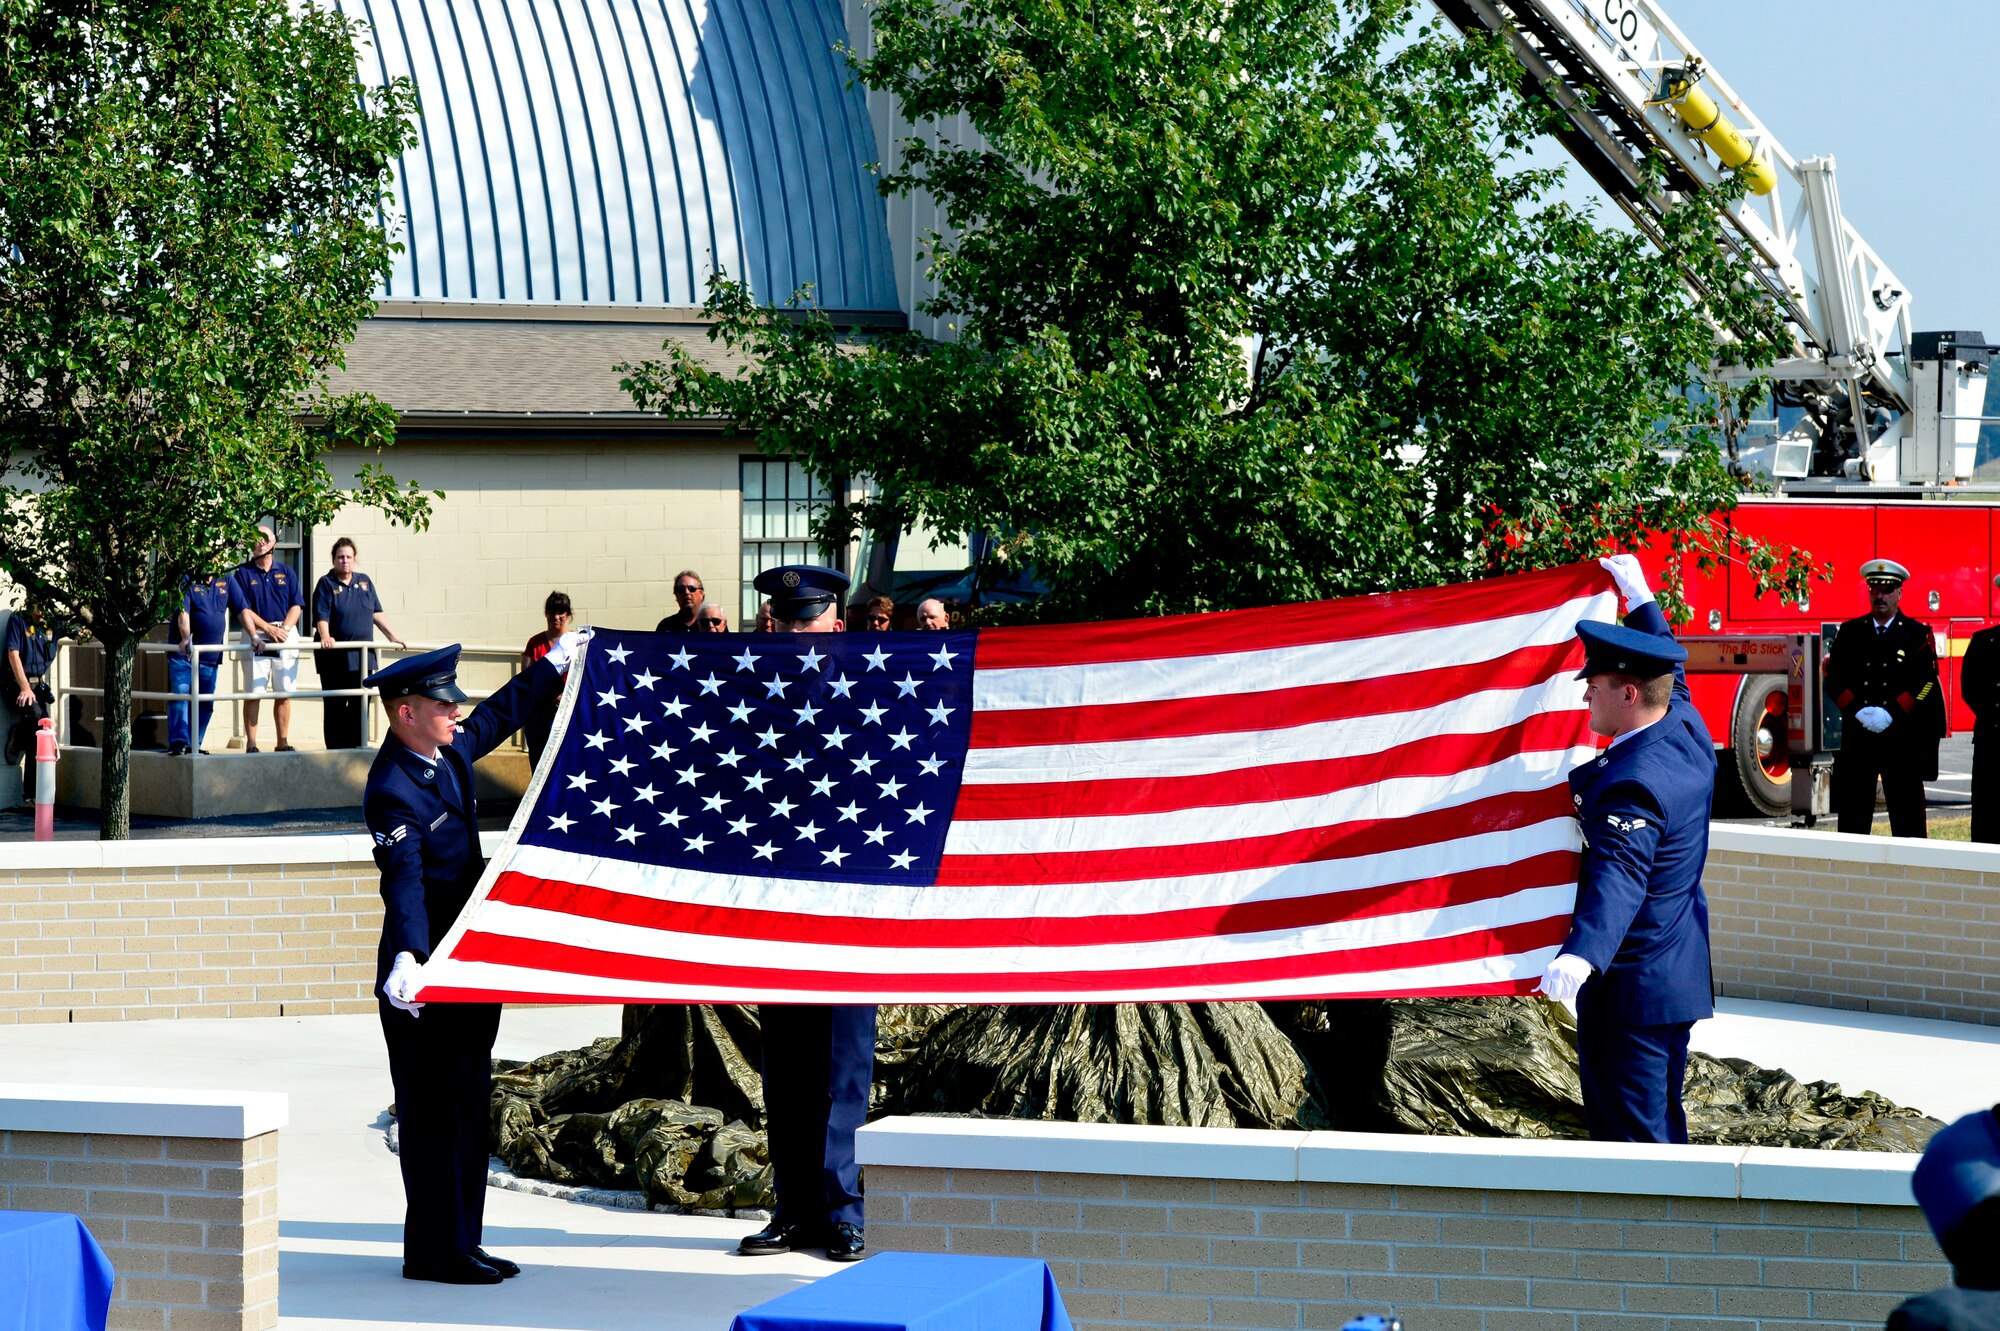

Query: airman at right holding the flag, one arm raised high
[1540,556,1716,1143]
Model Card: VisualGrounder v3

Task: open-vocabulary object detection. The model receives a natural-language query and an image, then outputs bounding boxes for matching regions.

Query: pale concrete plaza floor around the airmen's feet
[0,1001,2000,1331]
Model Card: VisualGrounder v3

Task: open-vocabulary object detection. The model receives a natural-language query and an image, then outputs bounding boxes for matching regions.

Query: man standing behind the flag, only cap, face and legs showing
[736,564,876,1261]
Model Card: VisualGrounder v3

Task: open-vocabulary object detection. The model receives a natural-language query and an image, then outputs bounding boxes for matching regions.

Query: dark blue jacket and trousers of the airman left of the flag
[362,662,562,1267]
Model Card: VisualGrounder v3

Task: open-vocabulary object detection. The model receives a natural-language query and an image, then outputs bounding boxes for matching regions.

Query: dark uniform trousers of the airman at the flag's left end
[376,985,500,1267]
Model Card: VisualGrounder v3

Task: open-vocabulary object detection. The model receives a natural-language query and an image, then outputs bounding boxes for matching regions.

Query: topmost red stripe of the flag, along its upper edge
[978,564,1610,669]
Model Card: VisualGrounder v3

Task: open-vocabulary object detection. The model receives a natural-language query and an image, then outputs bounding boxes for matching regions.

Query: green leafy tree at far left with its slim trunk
[0,0,428,837]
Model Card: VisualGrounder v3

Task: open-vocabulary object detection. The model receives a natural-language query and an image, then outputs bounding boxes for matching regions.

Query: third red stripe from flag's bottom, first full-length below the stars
[488,851,1576,947]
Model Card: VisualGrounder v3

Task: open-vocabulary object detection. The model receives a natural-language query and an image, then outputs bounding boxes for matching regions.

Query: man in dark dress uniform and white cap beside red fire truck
[1826,560,1944,837]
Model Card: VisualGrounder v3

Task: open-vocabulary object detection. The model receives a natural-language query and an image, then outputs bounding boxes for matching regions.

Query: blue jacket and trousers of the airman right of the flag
[1562,604,1716,1141]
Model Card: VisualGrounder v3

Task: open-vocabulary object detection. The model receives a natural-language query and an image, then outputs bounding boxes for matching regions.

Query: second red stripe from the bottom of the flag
[452,915,1570,999]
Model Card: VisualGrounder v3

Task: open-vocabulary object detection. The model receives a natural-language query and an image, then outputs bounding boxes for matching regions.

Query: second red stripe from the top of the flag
[972,638,1584,749]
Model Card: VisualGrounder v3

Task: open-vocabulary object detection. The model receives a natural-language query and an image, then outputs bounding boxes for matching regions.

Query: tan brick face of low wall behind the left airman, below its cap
[0,855,382,1023]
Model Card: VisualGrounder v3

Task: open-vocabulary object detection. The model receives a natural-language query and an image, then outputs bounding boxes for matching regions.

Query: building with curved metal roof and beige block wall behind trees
[310,0,916,663]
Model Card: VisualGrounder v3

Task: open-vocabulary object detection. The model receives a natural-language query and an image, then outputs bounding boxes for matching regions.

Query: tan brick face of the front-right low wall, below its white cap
[868,1163,1950,1331]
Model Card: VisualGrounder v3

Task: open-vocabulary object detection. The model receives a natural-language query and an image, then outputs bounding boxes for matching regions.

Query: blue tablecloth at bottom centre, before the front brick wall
[730,1253,1070,1331]
